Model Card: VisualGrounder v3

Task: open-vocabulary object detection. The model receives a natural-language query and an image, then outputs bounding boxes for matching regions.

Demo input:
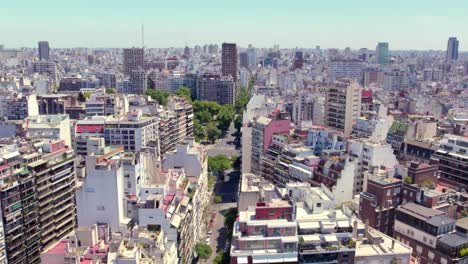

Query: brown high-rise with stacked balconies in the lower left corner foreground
[0,140,76,264]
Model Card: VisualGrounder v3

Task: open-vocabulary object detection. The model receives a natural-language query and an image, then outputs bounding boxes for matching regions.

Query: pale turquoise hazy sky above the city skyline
[0,0,468,50]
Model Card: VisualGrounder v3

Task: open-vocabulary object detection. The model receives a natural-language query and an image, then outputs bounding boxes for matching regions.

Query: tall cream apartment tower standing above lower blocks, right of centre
[325,79,362,136]
